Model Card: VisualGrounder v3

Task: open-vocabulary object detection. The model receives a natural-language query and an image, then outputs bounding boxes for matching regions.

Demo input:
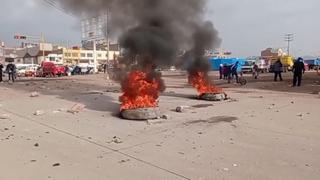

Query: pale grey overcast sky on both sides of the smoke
[0,0,320,57]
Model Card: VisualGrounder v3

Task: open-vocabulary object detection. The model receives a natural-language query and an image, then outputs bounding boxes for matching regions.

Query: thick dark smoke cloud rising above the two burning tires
[53,0,220,68]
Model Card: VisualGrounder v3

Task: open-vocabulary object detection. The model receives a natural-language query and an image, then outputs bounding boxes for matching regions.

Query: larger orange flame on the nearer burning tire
[120,71,161,111]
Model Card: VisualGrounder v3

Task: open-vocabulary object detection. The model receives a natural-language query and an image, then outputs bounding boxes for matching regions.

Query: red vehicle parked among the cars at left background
[41,62,66,77]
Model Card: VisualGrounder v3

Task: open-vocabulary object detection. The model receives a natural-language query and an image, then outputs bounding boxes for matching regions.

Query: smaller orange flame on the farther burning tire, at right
[189,72,224,96]
